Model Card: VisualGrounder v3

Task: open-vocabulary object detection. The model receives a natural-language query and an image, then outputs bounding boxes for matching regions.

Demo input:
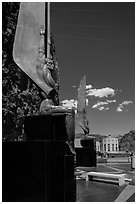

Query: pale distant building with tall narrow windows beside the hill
[102,136,119,153]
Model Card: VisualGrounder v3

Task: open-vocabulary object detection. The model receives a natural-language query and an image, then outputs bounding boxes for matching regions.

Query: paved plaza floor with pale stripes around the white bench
[77,162,135,202]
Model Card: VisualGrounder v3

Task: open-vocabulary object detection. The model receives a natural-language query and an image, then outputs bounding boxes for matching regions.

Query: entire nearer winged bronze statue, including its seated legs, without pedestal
[13,2,75,154]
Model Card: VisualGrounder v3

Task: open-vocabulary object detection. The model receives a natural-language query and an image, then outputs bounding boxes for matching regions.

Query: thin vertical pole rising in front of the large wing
[47,2,50,59]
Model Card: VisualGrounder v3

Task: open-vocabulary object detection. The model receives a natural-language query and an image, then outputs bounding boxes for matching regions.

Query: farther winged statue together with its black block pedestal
[76,76,96,167]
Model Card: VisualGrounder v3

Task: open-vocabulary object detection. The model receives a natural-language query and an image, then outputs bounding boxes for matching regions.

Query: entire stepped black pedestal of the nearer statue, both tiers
[2,114,76,202]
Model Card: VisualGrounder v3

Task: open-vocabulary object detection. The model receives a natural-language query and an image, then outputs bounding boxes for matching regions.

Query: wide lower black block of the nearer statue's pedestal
[2,141,76,202]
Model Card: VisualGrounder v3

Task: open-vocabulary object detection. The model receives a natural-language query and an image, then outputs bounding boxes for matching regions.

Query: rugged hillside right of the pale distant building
[119,130,135,152]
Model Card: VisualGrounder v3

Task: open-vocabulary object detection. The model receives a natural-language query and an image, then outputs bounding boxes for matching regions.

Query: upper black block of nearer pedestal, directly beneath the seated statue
[24,114,67,141]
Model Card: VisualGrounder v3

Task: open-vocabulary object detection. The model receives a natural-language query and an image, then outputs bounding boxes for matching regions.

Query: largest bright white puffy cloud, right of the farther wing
[86,87,115,98]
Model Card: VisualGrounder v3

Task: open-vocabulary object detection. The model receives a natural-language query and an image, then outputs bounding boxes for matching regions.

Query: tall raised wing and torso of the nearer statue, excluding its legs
[13,2,59,105]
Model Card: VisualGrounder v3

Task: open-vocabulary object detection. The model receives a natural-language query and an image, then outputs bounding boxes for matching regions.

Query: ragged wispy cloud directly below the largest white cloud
[92,99,116,111]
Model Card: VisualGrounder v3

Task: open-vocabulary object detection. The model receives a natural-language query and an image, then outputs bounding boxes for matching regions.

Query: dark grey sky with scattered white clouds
[51,2,135,135]
